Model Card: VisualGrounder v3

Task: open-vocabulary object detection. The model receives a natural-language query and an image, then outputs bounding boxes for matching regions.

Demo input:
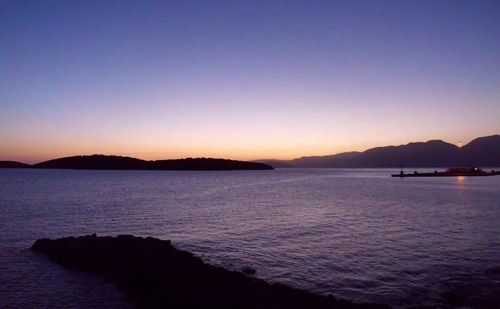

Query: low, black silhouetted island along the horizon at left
[0,155,273,171]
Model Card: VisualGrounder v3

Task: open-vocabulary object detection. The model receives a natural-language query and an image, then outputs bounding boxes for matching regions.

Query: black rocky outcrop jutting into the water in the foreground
[31,234,387,308]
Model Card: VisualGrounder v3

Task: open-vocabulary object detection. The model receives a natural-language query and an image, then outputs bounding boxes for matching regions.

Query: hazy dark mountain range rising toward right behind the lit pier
[255,135,500,168]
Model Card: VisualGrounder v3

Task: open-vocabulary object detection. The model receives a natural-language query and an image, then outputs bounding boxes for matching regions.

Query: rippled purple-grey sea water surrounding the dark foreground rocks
[0,169,500,308]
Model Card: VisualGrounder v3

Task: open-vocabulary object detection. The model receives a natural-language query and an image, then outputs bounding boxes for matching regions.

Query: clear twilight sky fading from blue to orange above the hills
[0,0,500,163]
